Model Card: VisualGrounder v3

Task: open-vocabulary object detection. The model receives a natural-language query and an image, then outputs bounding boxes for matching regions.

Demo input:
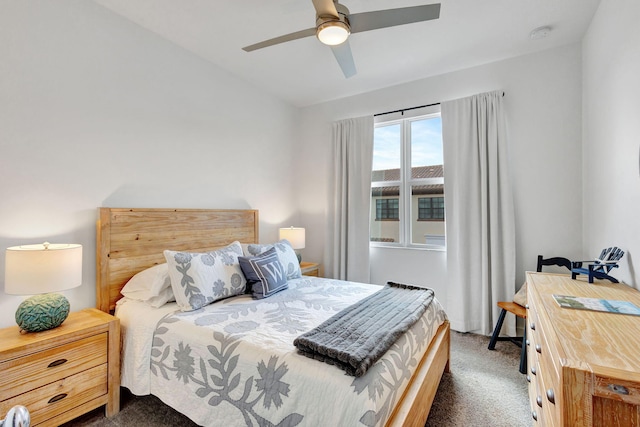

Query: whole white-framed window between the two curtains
[369,110,445,248]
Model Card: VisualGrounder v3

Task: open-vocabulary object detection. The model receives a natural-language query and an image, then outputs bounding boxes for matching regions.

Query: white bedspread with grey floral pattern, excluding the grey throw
[116,277,446,426]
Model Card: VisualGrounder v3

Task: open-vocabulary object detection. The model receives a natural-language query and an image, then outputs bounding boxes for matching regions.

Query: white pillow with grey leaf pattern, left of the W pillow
[164,242,247,311]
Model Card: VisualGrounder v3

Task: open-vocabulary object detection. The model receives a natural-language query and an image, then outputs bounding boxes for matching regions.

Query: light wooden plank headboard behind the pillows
[96,208,259,312]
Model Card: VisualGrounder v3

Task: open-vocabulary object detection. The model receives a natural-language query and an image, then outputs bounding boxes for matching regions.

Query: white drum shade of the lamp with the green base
[4,243,82,295]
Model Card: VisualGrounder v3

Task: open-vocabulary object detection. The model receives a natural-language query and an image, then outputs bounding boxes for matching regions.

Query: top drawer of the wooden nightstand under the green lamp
[0,332,108,405]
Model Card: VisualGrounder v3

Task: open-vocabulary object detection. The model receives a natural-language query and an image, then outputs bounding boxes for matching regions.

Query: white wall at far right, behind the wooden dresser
[583,0,640,288]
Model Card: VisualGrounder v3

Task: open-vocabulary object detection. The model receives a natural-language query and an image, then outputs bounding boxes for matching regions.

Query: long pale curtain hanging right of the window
[441,92,515,335]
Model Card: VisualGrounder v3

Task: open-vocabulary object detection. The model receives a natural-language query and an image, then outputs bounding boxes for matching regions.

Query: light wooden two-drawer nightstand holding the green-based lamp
[0,308,120,426]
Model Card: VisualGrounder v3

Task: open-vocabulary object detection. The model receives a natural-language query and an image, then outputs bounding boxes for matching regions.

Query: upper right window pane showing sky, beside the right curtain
[411,116,443,179]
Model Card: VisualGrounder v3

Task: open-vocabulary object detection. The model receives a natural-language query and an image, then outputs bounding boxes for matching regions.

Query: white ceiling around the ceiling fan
[94,0,600,106]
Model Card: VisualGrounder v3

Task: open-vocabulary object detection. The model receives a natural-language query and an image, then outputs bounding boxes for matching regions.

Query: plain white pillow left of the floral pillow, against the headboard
[120,263,175,308]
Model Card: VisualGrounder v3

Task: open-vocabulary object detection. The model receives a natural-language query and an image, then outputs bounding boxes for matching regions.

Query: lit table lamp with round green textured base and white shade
[4,242,82,333]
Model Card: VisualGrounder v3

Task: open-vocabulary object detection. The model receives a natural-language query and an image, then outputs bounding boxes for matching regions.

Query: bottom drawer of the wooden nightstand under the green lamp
[1,363,107,425]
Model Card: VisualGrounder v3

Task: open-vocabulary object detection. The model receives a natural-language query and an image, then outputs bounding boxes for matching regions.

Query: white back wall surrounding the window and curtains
[297,45,582,310]
